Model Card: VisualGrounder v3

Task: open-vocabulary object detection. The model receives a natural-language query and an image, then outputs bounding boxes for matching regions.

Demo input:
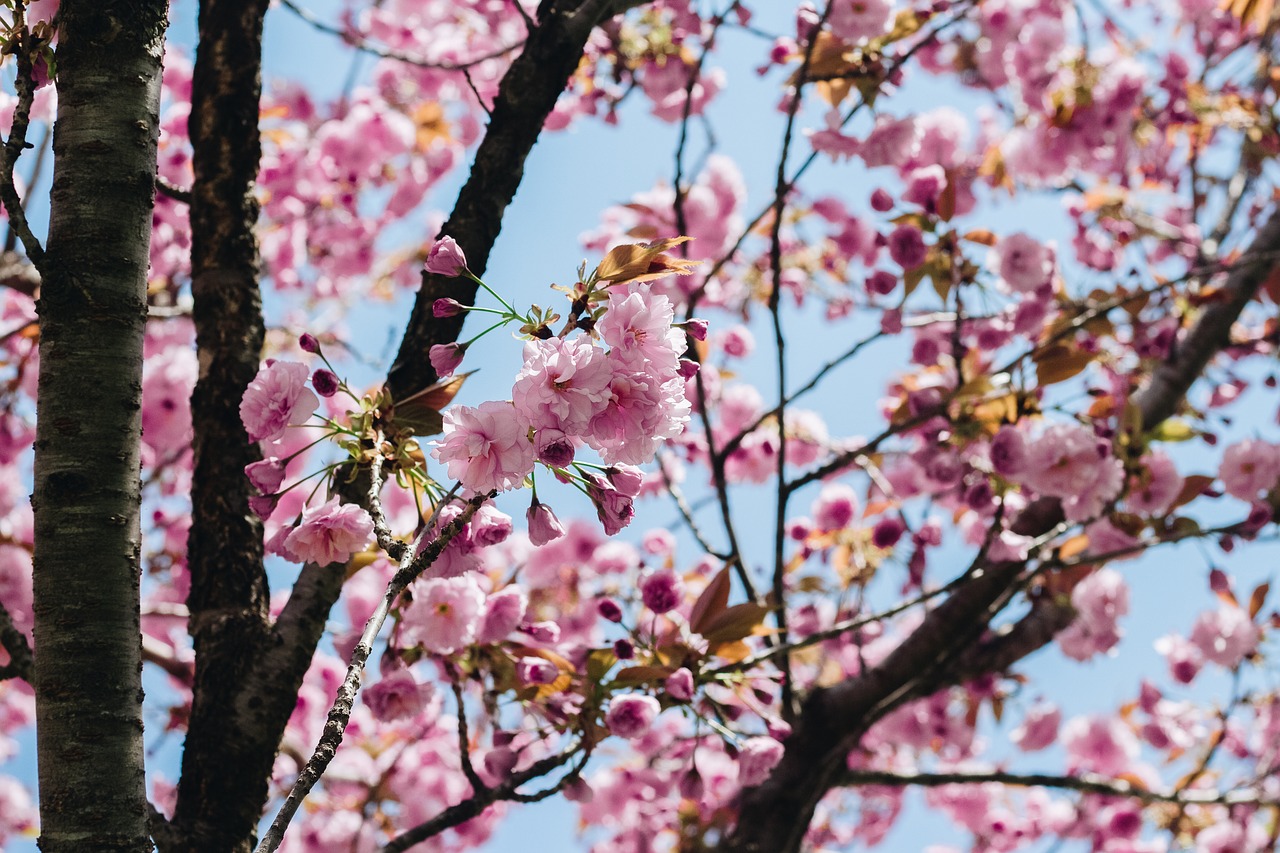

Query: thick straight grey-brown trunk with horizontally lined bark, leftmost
[32,0,166,853]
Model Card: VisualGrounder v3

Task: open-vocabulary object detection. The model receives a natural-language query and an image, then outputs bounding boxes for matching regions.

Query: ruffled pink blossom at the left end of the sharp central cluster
[431,401,534,492]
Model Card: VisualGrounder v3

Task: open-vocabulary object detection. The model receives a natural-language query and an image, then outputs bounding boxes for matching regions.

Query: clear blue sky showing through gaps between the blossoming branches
[6,0,1276,853]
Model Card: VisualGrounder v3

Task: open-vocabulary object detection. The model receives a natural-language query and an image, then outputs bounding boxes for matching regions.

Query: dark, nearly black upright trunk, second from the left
[166,0,273,850]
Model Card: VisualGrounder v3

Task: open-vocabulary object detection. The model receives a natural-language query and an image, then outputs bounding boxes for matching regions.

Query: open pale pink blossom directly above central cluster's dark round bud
[511,336,612,435]
